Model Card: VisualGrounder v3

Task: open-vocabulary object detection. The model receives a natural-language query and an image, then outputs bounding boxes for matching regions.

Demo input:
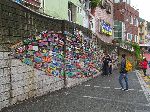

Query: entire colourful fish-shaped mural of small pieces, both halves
[12,30,102,78]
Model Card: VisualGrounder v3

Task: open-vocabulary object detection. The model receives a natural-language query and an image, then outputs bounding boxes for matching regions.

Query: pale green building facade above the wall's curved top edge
[43,0,90,28]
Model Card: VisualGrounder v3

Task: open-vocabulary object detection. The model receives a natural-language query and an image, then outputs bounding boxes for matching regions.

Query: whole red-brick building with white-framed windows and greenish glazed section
[114,2,139,43]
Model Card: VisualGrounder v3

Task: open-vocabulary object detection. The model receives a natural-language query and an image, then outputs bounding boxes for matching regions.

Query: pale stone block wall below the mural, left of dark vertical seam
[0,52,64,109]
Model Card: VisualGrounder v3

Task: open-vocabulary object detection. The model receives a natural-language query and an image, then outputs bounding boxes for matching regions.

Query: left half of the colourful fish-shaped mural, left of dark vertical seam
[15,31,64,77]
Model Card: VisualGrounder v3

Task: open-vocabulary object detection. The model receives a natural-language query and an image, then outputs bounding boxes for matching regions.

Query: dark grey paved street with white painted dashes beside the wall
[2,72,150,112]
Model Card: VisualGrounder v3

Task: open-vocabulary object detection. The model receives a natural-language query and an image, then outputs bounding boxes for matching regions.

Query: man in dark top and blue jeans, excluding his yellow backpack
[119,54,128,91]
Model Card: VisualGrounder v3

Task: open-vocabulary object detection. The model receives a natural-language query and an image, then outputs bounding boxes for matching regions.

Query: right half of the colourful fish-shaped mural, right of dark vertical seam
[66,30,99,78]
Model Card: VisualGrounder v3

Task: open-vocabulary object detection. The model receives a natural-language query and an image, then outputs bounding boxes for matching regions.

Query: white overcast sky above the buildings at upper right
[131,0,150,22]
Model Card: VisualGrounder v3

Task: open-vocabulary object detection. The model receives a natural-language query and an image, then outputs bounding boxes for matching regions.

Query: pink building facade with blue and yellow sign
[92,0,113,43]
